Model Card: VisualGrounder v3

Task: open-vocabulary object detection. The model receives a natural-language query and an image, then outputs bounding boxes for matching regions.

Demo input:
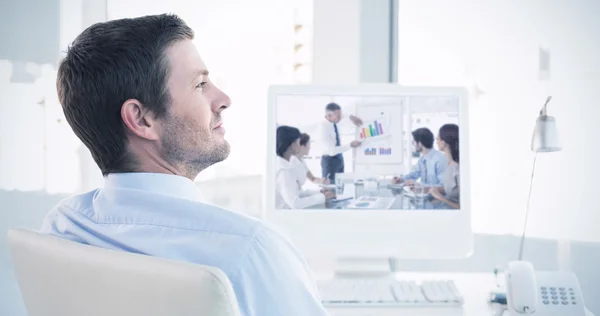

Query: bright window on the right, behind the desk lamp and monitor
[398,0,600,239]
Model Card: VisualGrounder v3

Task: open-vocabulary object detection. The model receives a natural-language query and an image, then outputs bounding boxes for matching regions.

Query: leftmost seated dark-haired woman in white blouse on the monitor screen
[275,126,333,209]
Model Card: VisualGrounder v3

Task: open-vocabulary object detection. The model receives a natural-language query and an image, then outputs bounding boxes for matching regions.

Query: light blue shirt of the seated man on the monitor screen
[402,149,448,186]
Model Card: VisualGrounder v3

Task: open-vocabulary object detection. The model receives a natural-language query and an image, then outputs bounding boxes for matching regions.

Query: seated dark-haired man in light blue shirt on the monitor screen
[393,127,448,187]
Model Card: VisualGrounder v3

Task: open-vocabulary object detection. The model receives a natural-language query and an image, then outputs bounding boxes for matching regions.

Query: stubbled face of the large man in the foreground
[161,40,231,177]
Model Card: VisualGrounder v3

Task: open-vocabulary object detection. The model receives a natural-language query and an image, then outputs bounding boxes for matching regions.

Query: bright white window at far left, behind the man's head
[0,60,81,193]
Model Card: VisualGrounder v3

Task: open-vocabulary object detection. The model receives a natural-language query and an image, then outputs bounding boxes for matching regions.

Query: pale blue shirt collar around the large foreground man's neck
[104,172,202,201]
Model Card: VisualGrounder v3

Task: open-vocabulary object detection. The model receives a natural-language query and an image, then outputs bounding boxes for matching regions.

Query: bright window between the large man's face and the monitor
[108,0,312,181]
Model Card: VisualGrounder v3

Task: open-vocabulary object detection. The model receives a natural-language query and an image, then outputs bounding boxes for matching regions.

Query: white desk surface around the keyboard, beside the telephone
[328,273,502,316]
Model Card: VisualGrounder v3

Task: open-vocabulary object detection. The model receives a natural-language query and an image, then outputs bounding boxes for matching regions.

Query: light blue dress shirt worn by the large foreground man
[41,173,327,316]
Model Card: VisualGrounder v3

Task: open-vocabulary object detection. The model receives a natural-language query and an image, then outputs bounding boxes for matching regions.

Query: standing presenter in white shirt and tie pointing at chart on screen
[320,102,362,183]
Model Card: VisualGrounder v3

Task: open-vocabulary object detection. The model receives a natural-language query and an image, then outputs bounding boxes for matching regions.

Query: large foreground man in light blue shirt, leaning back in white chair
[41,15,327,316]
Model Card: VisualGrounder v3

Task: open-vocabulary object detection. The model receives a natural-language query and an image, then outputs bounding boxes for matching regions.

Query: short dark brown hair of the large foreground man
[56,14,194,176]
